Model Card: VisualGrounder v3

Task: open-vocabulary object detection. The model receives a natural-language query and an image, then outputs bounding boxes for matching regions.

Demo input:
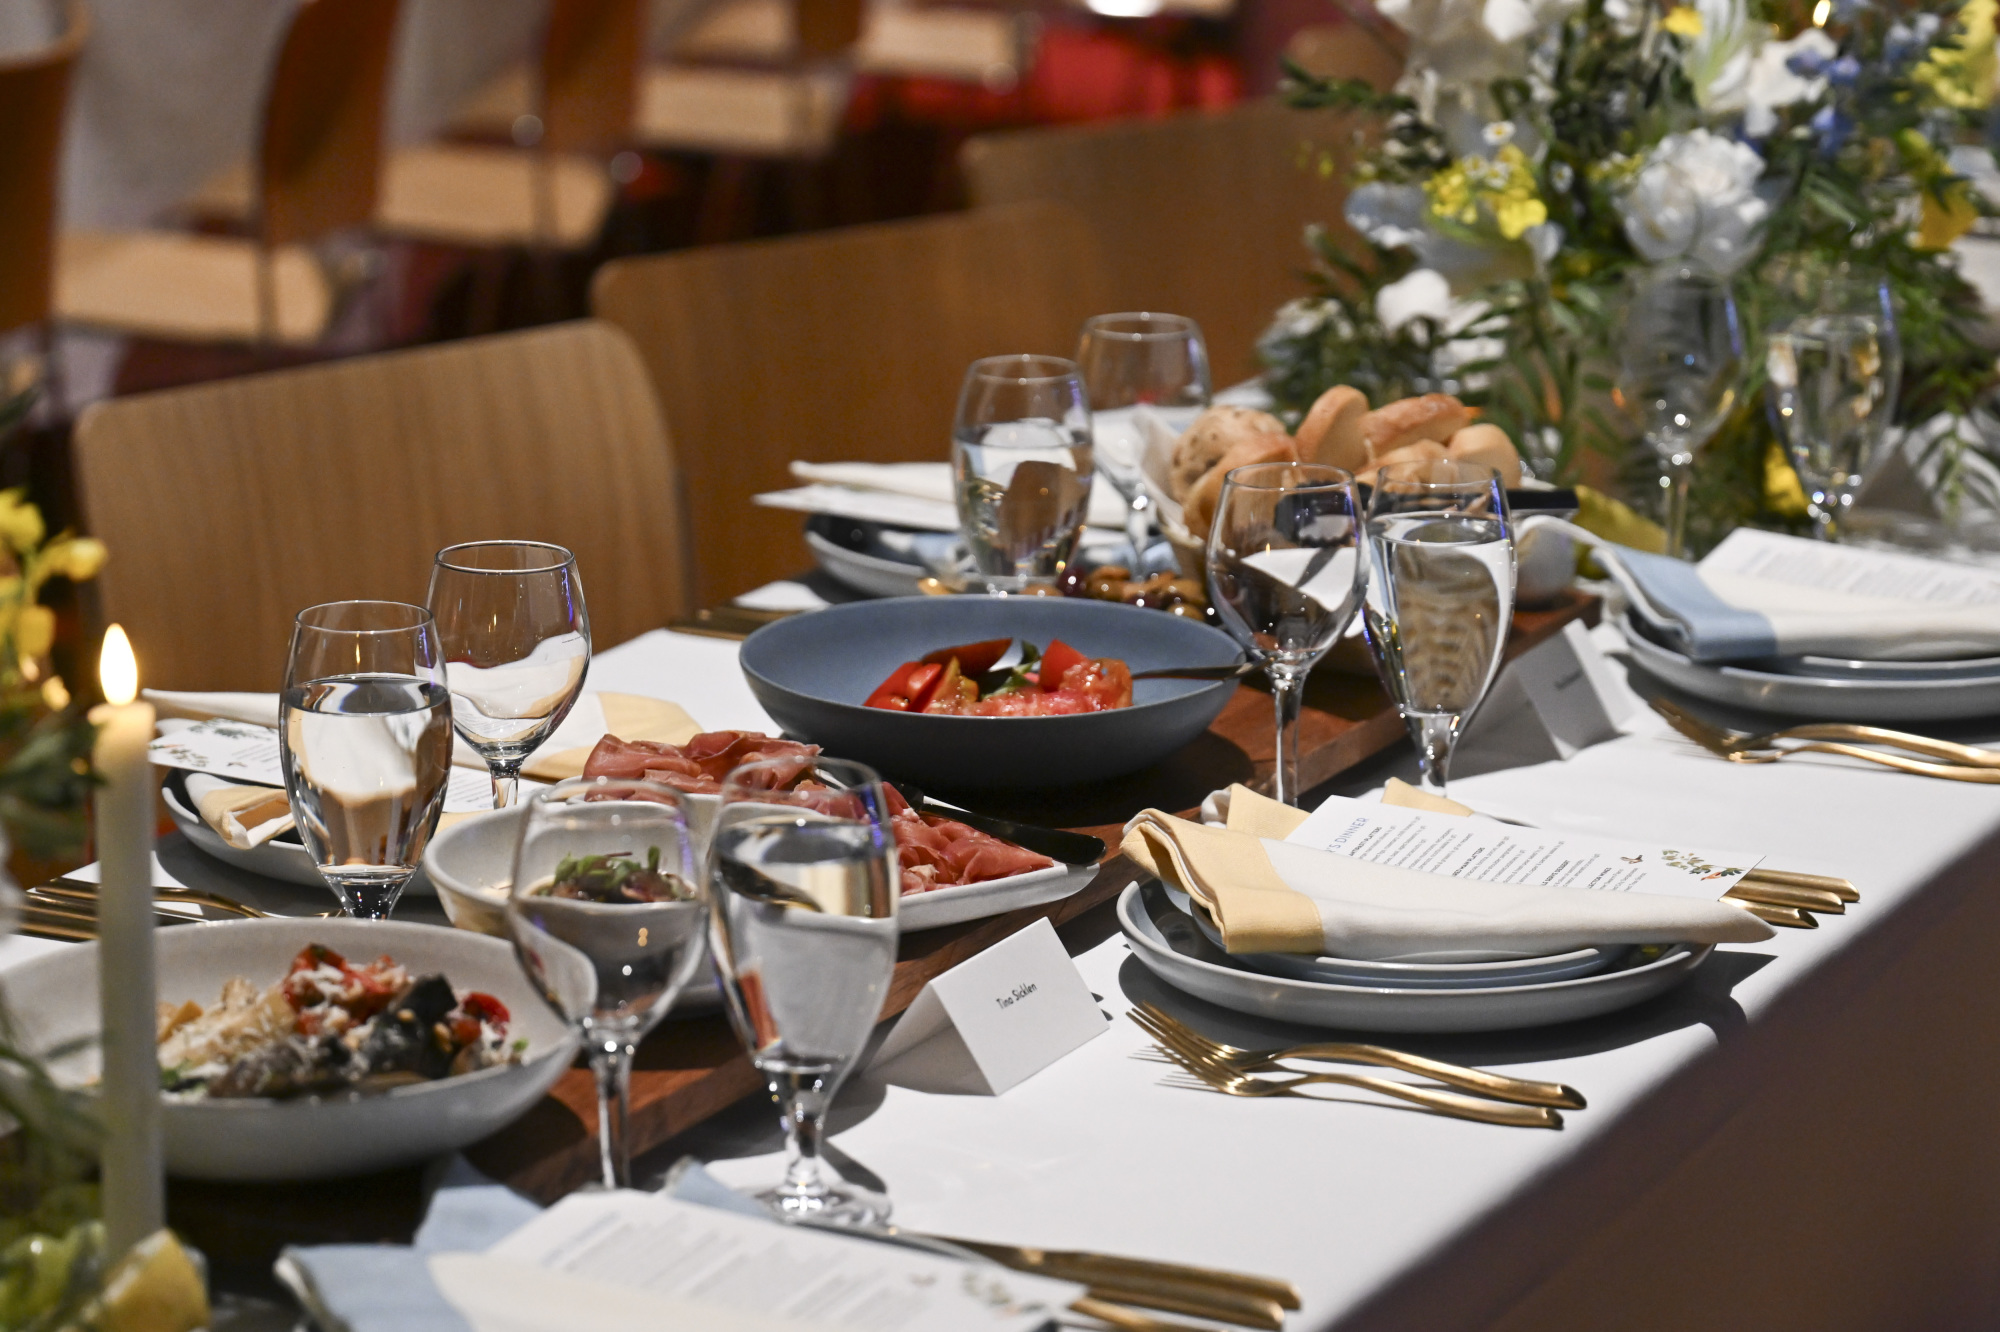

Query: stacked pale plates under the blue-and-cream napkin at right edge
[1618,620,2000,722]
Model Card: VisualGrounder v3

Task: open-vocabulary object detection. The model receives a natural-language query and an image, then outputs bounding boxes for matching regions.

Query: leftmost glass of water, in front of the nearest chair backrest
[278,602,452,920]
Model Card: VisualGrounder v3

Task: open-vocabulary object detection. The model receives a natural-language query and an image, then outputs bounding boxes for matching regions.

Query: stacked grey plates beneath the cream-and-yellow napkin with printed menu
[1118,882,1714,1032]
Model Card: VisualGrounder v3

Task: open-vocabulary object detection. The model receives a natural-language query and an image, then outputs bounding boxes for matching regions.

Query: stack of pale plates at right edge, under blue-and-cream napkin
[1618,616,2000,722]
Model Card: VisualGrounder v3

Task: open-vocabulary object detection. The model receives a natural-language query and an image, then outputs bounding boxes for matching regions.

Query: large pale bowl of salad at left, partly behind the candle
[0,918,576,1180]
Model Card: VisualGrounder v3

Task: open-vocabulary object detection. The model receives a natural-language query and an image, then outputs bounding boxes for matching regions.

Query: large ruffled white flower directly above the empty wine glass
[1618,130,1770,278]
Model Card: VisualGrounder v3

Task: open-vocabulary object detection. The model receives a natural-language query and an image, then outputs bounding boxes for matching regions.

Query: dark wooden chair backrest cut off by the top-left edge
[0,0,90,330]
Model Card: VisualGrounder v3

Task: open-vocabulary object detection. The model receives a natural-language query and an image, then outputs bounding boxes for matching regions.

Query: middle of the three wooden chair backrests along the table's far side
[590,204,1104,606]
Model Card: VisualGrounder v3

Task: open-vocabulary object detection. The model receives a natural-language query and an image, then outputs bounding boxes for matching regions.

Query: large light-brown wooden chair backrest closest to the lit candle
[74,320,688,690]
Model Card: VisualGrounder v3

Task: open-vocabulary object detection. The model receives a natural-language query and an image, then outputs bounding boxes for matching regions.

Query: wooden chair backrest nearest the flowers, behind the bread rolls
[960,102,1376,386]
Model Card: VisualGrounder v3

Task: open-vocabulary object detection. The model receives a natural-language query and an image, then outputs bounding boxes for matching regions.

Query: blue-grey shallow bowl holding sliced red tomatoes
[742,596,1242,790]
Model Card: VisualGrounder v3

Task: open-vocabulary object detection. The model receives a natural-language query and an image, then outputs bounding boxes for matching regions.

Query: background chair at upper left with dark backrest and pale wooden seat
[56,0,398,346]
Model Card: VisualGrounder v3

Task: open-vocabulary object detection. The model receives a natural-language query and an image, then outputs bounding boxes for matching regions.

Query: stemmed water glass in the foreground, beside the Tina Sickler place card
[708,758,898,1226]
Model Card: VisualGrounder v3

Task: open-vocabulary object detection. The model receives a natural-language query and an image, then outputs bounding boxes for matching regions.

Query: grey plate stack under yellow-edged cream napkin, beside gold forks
[1118,882,1714,1032]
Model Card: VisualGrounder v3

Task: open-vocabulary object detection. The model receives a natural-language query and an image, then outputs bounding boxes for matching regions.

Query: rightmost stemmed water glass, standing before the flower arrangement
[1764,314,1902,540]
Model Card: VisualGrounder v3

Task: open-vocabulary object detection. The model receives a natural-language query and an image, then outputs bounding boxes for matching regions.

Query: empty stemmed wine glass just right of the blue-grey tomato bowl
[1208,462,1366,804]
